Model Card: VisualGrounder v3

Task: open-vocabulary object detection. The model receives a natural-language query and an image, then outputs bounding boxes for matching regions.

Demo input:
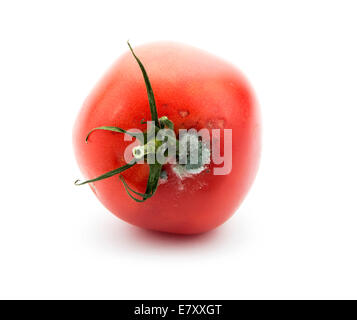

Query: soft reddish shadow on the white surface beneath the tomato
[94,217,246,255]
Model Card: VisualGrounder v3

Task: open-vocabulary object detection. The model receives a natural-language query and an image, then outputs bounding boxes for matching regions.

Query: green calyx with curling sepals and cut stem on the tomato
[74,41,178,202]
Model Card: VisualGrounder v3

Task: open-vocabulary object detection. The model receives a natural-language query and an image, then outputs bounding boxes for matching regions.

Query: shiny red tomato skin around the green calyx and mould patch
[73,42,261,234]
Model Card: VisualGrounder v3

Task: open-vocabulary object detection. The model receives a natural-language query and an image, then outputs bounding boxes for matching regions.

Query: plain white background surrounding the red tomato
[0,0,357,299]
